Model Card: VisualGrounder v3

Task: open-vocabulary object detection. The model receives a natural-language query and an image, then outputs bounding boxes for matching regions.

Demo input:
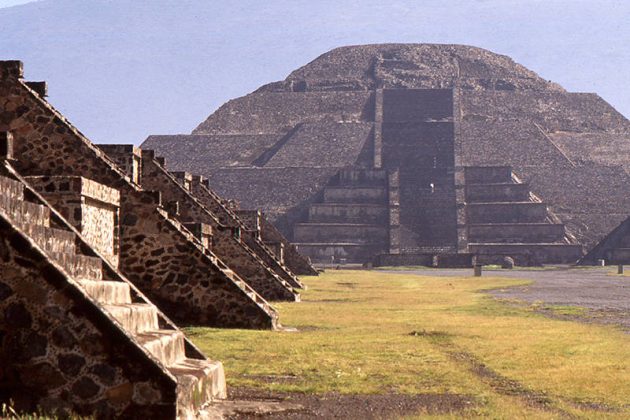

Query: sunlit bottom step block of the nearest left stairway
[168,358,227,418]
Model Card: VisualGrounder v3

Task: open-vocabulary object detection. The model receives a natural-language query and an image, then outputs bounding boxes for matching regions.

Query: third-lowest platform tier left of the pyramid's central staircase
[308,203,389,223]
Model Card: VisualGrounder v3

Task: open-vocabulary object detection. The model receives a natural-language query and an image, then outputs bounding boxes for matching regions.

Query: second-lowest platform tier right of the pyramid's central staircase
[468,223,565,243]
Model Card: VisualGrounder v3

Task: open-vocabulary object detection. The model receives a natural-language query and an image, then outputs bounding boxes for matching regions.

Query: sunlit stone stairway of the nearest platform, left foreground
[0,173,227,418]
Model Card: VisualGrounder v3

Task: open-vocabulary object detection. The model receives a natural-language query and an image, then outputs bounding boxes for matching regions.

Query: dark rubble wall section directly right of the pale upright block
[121,193,277,328]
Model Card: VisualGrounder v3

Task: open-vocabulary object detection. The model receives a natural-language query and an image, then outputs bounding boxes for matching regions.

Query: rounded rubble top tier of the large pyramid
[276,44,562,92]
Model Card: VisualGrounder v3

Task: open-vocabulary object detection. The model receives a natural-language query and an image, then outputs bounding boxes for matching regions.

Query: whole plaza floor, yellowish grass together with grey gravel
[187,269,630,418]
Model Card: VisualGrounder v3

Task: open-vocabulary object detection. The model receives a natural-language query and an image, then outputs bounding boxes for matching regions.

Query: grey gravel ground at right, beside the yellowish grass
[386,266,630,332]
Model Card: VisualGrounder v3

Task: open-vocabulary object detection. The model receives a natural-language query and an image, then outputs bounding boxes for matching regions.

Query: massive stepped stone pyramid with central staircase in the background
[142,44,630,263]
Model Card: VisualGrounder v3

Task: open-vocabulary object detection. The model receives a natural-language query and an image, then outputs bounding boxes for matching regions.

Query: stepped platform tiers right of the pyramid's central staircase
[465,166,582,265]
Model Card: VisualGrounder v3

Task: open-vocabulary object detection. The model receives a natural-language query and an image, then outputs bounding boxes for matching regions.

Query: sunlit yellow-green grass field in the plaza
[187,271,630,418]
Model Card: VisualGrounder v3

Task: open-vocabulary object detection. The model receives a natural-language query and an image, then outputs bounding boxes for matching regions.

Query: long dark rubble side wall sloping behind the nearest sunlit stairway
[0,65,277,328]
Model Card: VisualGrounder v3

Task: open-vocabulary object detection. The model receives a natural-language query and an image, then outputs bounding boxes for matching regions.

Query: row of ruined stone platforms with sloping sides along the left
[0,61,314,418]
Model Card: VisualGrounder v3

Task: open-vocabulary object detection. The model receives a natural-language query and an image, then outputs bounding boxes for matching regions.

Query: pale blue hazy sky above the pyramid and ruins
[0,0,630,144]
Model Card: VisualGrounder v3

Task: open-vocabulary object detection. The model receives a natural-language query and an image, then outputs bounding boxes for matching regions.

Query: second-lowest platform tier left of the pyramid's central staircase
[293,223,389,244]
